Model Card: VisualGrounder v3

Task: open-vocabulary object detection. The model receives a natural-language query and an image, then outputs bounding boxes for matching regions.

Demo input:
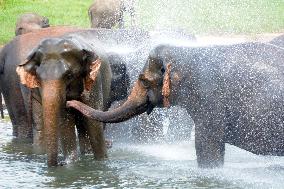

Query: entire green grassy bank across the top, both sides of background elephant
[0,0,284,45]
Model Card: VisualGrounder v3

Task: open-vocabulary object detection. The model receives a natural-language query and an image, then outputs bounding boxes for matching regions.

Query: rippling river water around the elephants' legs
[0,111,284,189]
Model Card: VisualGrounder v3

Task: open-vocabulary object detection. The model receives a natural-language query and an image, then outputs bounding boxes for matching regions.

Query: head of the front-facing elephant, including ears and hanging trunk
[17,38,101,166]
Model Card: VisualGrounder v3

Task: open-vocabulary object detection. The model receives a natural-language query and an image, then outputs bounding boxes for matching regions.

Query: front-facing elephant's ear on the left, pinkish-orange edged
[16,51,40,89]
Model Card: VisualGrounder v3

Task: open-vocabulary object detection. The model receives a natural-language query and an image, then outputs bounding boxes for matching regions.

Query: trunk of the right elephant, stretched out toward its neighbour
[67,81,150,123]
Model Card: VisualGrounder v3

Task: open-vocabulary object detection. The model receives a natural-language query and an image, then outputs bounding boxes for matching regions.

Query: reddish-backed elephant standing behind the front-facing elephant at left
[0,26,80,140]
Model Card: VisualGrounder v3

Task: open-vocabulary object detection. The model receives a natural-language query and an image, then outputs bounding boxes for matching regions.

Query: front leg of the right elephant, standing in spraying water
[195,120,225,168]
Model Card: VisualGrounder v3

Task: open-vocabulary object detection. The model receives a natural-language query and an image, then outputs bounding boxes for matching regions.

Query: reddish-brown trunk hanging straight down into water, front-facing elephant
[42,80,65,167]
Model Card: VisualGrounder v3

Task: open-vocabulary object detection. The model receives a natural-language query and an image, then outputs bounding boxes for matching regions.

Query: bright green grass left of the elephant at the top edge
[0,0,93,44]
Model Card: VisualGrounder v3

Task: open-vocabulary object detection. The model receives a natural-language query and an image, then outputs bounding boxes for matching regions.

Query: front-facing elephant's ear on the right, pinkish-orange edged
[83,50,102,91]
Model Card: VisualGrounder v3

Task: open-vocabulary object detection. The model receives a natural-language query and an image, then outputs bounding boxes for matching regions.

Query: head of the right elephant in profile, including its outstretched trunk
[67,45,172,123]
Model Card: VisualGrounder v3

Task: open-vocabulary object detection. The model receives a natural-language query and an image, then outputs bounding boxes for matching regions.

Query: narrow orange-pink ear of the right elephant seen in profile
[162,63,172,107]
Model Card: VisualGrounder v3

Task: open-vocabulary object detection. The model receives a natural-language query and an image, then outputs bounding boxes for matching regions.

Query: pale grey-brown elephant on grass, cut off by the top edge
[88,0,135,29]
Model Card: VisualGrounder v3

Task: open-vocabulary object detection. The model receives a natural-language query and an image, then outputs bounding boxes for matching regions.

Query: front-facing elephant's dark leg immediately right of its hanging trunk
[59,112,78,161]
